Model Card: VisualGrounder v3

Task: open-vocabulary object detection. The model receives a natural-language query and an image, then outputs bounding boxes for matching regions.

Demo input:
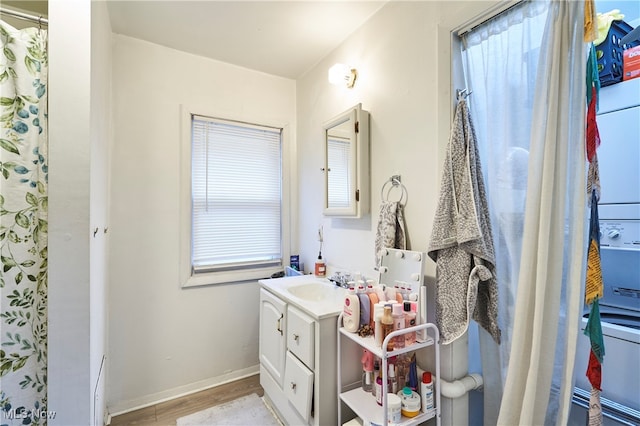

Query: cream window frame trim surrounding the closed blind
[179,104,292,288]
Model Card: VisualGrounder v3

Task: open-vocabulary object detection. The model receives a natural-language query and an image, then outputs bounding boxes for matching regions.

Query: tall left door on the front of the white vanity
[259,289,287,388]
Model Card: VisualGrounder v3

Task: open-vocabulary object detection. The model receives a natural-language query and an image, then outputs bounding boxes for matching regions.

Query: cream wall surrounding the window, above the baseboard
[108,35,296,414]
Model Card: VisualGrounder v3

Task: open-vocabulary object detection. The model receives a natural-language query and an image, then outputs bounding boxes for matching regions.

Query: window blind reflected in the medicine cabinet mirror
[327,137,354,208]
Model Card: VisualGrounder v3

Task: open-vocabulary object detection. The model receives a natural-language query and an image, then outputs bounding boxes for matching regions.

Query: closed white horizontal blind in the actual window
[191,115,282,273]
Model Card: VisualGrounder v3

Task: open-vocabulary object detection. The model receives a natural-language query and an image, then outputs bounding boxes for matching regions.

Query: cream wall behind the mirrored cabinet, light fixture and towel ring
[297,1,496,424]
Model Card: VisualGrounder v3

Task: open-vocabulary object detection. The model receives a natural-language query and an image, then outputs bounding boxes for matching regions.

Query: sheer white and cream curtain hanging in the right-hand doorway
[464,1,586,425]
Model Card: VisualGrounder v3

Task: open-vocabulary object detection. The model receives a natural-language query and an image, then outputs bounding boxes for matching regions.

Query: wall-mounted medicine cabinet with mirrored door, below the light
[322,104,370,218]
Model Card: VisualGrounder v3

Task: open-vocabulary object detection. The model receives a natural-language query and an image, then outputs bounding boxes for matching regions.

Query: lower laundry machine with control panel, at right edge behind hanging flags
[574,205,640,425]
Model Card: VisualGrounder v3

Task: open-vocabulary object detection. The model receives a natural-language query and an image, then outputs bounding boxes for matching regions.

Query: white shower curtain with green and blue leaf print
[0,21,48,425]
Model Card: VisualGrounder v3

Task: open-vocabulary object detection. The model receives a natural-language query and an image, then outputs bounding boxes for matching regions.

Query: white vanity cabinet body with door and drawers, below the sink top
[259,286,341,426]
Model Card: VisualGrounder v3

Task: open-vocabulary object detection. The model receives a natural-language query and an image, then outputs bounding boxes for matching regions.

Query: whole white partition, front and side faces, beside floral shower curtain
[48,0,111,426]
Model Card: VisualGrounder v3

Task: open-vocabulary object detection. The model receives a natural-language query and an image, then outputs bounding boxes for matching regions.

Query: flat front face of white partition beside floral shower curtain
[47,0,92,426]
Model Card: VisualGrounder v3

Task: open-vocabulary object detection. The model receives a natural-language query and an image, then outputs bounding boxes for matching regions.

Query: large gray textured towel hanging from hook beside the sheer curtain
[428,100,500,344]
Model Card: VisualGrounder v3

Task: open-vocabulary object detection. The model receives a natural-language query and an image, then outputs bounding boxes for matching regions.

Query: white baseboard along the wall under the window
[107,365,260,420]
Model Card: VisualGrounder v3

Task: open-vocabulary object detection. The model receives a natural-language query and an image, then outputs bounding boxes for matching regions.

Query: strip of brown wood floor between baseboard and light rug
[110,374,264,426]
